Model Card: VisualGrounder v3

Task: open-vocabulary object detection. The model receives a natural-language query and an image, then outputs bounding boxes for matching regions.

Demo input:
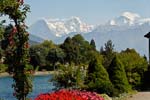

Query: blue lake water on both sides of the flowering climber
[0,75,54,100]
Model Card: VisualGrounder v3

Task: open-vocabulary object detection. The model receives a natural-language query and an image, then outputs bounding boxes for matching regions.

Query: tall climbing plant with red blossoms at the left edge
[0,0,32,100]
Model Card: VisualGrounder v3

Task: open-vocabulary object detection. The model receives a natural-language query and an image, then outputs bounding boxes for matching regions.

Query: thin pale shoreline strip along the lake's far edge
[0,71,54,78]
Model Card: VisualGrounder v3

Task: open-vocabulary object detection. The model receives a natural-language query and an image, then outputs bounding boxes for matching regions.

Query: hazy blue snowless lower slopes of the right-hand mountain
[84,23,150,55]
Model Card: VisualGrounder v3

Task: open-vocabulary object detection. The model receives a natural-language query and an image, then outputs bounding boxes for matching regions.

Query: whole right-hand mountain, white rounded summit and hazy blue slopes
[84,12,150,55]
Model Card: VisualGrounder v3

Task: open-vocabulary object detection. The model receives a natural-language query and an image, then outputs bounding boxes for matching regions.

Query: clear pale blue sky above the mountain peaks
[25,0,150,25]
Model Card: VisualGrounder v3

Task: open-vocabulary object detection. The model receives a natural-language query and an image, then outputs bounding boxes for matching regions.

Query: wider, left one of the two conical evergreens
[85,57,113,95]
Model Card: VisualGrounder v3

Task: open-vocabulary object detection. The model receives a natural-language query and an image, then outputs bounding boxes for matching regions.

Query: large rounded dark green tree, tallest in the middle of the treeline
[60,34,92,65]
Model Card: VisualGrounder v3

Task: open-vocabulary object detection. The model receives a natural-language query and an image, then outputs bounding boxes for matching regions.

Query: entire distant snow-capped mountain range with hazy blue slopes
[29,12,150,55]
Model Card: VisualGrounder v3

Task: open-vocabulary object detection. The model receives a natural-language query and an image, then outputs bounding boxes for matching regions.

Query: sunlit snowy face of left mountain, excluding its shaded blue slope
[47,17,94,37]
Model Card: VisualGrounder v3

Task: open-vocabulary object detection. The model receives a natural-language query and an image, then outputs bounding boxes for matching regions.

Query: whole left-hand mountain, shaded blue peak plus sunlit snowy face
[29,17,94,40]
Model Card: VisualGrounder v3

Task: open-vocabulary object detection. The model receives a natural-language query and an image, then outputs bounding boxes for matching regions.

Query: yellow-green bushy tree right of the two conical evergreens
[119,49,148,89]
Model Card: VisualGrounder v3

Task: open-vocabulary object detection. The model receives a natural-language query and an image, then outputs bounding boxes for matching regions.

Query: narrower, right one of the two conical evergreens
[108,56,131,95]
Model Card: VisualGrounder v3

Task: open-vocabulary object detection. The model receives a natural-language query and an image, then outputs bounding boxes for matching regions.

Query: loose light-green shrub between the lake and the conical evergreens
[54,64,85,89]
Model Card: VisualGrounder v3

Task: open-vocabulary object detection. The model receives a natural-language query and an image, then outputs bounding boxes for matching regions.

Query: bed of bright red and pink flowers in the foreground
[35,89,104,100]
